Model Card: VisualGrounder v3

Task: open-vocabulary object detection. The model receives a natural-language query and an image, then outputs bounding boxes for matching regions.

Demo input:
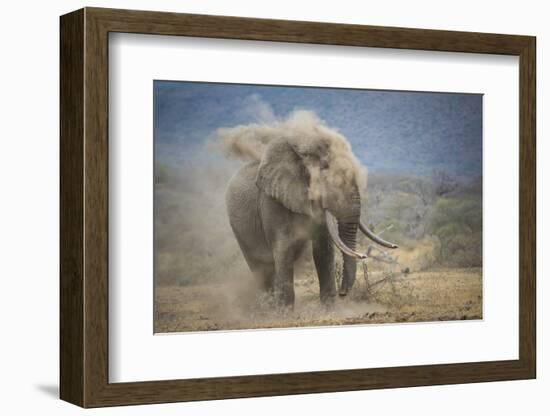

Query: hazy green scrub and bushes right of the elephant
[362,175,482,268]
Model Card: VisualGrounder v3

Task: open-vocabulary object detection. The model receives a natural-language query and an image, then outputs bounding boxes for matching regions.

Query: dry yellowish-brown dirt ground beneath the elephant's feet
[155,268,482,333]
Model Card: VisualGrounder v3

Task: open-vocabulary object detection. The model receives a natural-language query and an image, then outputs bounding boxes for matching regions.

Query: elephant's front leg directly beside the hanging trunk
[312,227,336,304]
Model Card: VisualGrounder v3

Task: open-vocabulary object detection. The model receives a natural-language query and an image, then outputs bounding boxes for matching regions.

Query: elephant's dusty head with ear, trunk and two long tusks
[256,124,397,296]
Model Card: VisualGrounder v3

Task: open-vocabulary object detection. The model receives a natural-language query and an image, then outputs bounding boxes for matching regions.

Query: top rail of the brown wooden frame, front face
[90,8,529,55]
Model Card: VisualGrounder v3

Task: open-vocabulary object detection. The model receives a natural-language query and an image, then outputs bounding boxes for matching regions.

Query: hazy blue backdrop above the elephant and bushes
[153,81,482,176]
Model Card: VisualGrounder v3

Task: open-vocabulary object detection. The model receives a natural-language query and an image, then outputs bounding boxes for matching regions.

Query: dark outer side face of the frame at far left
[59,10,85,406]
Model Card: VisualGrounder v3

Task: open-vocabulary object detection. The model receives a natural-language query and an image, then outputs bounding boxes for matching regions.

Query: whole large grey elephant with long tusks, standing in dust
[225,118,397,308]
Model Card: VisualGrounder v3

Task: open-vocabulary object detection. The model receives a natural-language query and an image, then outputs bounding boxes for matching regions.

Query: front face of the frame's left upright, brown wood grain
[84,12,109,406]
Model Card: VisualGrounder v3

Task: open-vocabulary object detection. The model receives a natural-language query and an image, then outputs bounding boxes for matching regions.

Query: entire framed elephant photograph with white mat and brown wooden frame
[60,8,536,407]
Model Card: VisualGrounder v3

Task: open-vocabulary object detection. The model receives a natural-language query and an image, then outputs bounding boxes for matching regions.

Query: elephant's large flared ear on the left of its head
[256,140,311,215]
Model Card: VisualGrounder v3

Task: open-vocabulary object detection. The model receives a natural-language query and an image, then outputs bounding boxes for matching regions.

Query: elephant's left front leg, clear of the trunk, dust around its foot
[273,247,295,308]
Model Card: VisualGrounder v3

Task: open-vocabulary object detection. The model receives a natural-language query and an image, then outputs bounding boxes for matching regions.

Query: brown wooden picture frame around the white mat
[60,8,536,407]
